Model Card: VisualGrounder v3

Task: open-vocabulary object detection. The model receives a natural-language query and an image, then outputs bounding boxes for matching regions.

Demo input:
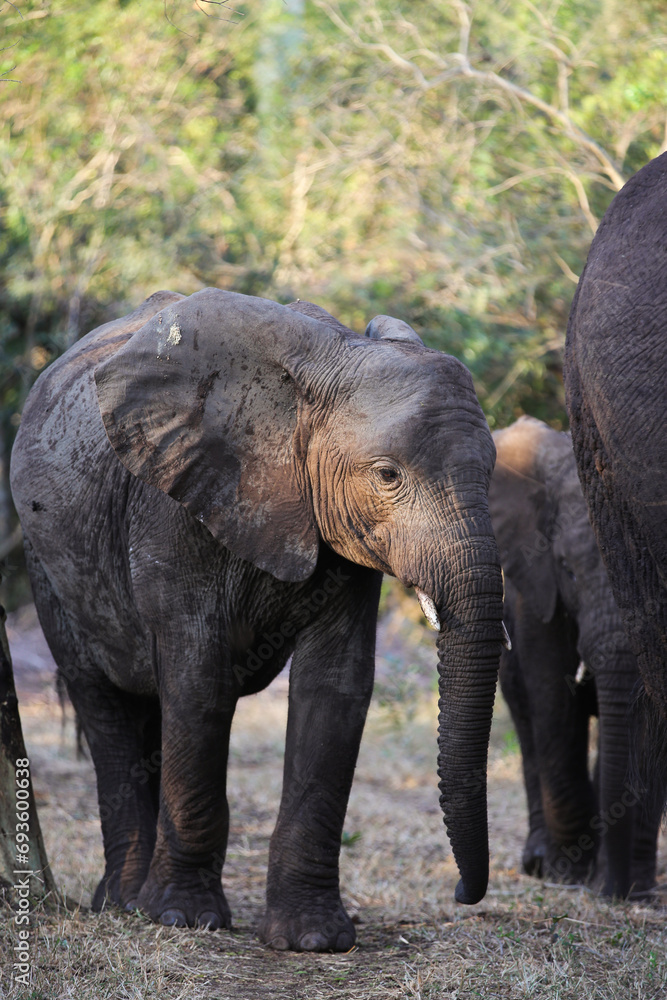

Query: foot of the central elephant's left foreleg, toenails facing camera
[136,872,232,931]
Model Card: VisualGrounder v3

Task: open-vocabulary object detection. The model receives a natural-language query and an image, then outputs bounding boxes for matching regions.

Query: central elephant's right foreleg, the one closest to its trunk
[259,580,375,951]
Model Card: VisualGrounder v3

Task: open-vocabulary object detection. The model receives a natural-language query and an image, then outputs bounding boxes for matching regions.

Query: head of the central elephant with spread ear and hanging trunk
[96,289,503,903]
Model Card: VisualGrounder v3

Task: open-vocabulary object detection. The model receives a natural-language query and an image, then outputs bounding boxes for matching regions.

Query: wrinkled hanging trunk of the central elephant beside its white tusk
[436,527,503,903]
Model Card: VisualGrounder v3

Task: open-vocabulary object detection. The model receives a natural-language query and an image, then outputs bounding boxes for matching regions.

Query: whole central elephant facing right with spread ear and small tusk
[12,289,502,951]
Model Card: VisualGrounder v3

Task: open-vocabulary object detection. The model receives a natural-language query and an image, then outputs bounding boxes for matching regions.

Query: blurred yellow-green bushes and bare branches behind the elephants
[0,0,667,603]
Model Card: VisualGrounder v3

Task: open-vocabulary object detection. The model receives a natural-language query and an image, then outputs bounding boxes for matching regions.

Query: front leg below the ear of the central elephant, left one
[137,640,236,930]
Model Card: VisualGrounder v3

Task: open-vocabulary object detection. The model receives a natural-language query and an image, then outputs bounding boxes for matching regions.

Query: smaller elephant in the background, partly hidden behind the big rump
[489,417,659,896]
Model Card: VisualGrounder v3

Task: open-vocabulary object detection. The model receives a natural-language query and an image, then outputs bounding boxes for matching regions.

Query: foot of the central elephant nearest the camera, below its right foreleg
[258,902,357,951]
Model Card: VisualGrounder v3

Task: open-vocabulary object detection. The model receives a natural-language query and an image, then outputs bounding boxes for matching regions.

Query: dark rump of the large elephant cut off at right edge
[564,153,667,752]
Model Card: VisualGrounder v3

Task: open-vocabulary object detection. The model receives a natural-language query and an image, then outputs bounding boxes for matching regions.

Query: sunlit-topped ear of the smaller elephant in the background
[489,417,558,622]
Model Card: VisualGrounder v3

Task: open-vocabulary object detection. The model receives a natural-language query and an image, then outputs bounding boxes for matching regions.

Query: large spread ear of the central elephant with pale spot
[95,288,353,581]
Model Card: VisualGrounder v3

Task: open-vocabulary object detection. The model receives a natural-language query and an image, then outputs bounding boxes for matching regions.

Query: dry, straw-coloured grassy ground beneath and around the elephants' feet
[0,595,667,1000]
